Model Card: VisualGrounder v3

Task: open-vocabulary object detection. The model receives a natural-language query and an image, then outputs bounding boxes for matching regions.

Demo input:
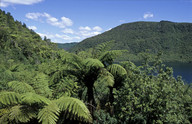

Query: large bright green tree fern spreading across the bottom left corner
[0,81,92,124]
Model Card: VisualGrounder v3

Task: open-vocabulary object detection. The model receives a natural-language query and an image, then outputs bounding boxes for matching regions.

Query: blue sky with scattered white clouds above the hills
[0,0,192,43]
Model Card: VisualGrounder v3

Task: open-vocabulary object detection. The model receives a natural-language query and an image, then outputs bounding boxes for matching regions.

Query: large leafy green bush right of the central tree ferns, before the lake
[115,61,192,124]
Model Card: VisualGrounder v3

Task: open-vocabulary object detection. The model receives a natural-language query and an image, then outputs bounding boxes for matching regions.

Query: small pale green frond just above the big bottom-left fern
[8,81,35,93]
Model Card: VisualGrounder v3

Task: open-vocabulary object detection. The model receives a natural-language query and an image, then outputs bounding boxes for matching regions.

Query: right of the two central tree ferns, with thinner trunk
[78,41,127,115]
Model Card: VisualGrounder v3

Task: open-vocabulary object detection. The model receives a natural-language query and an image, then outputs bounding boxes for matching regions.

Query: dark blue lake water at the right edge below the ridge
[165,63,192,83]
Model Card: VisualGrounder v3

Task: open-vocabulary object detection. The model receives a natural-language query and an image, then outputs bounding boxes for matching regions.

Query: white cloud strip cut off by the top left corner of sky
[0,0,43,7]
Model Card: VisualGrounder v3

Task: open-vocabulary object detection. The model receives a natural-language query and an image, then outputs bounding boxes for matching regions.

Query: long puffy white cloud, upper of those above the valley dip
[25,13,73,28]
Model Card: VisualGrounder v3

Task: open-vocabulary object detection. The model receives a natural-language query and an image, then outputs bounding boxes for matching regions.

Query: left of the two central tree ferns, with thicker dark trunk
[49,51,104,113]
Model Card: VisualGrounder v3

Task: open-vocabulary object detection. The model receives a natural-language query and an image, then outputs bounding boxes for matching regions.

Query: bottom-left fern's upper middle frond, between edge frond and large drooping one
[21,93,51,105]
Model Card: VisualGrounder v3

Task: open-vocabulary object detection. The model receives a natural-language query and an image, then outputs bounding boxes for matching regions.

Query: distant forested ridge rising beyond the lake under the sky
[69,21,192,63]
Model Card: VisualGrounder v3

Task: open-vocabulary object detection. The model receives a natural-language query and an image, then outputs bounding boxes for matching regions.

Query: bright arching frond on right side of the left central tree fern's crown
[83,58,104,68]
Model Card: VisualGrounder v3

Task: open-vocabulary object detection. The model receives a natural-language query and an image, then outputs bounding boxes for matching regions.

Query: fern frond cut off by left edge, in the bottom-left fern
[0,91,21,105]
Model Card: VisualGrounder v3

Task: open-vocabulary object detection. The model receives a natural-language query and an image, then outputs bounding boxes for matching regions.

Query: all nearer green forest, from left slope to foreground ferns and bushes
[0,10,192,124]
